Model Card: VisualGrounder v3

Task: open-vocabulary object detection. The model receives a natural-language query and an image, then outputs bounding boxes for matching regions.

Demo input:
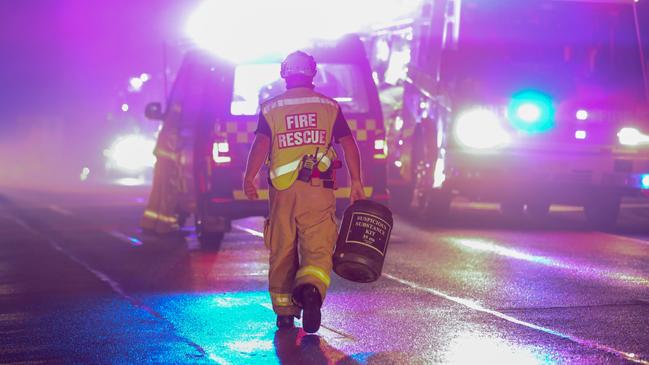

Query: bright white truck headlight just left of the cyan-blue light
[455,108,511,149]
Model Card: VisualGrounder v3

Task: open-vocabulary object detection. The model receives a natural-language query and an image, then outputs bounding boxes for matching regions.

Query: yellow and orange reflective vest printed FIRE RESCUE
[261,88,339,190]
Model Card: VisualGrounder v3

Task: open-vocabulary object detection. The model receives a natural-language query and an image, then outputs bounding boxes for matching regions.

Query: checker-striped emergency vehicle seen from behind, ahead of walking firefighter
[146,35,388,243]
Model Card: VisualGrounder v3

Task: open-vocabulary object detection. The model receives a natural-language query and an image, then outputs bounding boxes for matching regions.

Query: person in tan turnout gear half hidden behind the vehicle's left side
[140,106,181,235]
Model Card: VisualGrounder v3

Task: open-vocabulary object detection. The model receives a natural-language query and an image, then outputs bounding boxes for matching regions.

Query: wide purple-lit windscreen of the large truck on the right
[453,0,643,98]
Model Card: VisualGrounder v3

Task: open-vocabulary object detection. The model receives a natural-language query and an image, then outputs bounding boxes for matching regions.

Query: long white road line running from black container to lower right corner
[382,273,649,365]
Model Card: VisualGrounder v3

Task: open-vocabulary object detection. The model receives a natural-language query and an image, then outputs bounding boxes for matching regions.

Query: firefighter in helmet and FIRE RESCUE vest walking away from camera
[243,51,365,333]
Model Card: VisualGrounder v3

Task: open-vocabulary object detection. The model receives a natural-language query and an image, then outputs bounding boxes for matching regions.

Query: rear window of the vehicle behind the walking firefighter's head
[230,63,369,115]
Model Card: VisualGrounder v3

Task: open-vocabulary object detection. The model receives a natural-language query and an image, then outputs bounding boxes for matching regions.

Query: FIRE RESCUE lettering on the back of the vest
[277,113,327,148]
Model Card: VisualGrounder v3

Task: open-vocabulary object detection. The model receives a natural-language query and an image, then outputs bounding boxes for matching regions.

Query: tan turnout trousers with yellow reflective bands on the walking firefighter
[264,179,337,317]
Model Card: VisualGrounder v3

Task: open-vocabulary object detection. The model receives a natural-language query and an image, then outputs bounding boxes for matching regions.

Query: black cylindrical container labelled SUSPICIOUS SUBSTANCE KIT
[333,200,393,283]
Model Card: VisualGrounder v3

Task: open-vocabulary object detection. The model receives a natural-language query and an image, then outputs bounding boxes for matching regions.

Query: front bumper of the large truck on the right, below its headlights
[444,151,649,203]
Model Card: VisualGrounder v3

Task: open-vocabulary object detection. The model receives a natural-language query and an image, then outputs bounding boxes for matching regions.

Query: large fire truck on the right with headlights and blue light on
[368,0,649,228]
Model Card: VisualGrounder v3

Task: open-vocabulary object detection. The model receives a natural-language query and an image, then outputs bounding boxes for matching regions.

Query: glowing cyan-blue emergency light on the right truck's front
[507,91,555,133]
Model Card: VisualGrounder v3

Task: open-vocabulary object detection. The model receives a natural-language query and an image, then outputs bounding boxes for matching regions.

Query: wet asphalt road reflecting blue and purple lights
[0,189,649,364]
